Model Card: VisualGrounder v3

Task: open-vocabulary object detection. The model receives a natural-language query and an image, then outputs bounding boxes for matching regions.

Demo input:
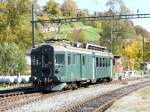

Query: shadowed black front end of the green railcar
[30,45,64,90]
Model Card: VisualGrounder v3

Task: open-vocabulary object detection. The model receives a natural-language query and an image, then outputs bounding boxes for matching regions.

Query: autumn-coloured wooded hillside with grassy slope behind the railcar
[0,0,150,74]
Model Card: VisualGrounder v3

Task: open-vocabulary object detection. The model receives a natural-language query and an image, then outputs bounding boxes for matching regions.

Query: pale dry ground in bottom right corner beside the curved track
[106,87,150,112]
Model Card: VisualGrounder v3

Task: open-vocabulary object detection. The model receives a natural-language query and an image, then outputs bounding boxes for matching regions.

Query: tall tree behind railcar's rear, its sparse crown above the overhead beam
[101,0,136,55]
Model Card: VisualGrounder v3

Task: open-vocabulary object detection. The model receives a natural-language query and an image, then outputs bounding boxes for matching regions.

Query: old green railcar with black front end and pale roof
[31,43,113,90]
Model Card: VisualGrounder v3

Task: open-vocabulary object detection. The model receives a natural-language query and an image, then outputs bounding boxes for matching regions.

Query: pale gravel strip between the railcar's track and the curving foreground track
[7,79,148,112]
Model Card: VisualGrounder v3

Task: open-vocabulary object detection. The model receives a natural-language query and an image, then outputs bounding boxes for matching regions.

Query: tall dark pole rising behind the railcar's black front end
[32,3,35,48]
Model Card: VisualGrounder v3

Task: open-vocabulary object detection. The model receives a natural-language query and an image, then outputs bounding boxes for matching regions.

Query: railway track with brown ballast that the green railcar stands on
[0,78,148,112]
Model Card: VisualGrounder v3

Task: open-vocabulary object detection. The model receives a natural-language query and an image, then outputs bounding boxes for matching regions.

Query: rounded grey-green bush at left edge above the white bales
[0,43,26,74]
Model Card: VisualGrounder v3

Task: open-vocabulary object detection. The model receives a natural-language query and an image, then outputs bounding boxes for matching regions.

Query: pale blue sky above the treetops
[39,0,150,31]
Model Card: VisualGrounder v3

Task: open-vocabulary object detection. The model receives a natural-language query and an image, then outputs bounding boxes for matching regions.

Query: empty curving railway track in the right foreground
[57,81,150,112]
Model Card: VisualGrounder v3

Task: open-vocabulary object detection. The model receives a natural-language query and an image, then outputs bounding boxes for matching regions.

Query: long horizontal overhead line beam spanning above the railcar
[34,13,150,23]
